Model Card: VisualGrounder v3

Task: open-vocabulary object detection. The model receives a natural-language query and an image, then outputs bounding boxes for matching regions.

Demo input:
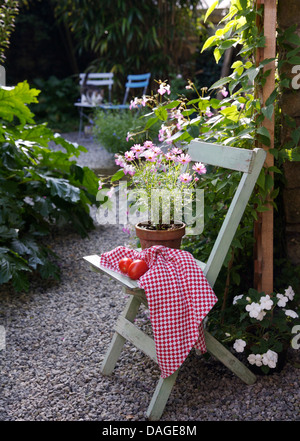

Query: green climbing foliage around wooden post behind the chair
[124,0,300,309]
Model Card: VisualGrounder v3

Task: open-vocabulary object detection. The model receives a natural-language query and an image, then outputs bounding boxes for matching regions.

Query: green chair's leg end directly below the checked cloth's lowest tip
[147,369,179,421]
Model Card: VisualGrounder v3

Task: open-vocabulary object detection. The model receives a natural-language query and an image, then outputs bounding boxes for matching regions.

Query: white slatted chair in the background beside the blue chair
[74,72,114,137]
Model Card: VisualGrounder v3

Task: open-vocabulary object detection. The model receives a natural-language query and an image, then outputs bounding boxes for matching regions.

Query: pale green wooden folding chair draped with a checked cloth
[84,140,266,420]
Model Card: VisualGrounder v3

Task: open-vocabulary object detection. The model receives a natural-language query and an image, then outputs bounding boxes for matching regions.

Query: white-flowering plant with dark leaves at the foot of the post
[226,286,300,373]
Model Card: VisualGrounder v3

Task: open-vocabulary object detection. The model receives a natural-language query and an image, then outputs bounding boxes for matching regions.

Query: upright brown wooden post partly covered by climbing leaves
[254,0,277,294]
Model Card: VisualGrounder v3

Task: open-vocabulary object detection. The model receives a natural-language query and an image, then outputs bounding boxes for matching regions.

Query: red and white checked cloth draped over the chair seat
[100,245,218,378]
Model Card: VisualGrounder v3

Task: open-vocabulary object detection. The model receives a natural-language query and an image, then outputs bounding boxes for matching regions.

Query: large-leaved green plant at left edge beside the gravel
[0,82,97,290]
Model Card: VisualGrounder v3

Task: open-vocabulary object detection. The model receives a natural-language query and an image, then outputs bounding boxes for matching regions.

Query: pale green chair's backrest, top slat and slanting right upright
[188,140,266,286]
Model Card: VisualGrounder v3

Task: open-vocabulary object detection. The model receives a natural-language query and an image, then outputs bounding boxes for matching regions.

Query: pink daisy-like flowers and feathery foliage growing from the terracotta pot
[106,141,206,230]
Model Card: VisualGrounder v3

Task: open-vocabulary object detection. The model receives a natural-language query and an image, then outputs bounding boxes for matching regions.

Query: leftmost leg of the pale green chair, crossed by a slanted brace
[101,296,141,375]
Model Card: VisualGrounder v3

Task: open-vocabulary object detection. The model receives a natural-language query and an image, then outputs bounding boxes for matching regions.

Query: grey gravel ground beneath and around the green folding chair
[0,132,300,421]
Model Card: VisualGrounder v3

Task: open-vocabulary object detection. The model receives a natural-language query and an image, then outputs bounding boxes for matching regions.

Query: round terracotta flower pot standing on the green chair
[135,222,185,250]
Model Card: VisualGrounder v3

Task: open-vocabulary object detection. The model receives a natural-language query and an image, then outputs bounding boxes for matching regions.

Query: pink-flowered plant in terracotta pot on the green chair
[112,141,206,249]
